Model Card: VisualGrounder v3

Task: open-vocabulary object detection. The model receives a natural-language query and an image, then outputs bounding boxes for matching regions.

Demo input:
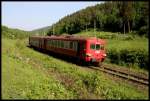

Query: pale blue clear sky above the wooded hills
[2,1,102,31]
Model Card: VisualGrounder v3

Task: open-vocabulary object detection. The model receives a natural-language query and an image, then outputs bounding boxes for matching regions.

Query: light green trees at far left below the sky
[1,26,33,39]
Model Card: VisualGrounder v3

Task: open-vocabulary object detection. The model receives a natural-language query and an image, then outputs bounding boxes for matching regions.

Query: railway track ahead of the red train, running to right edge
[90,66,149,86]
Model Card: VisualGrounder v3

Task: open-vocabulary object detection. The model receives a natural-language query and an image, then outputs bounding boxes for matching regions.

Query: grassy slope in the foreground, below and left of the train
[2,39,149,99]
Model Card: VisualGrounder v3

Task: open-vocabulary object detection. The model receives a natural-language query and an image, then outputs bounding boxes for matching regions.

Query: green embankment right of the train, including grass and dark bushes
[77,31,149,70]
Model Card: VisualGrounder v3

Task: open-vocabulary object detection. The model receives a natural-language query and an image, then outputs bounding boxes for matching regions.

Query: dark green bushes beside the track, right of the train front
[108,49,149,69]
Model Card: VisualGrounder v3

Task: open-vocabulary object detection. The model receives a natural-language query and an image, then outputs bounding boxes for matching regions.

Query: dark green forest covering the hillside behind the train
[48,1,149,36]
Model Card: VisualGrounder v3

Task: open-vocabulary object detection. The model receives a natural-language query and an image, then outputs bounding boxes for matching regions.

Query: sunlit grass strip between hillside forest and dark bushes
[76,31,148,51]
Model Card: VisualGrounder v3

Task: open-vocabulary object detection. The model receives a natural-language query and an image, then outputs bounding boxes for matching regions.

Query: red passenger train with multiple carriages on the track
[29,35,107,66]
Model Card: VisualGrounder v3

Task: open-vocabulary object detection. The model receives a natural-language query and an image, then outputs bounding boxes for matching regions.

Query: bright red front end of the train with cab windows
[85,38,106,65]
